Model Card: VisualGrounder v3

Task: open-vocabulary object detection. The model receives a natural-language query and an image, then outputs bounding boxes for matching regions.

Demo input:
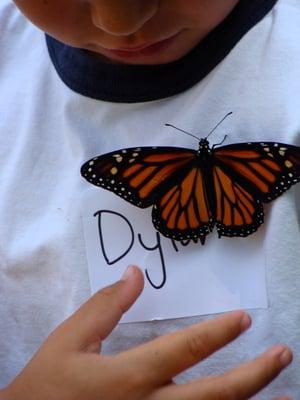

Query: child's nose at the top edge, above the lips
[92,0,160,36]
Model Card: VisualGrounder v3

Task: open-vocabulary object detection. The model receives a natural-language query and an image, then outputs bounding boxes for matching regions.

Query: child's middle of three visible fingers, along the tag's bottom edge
[118,311,251,384]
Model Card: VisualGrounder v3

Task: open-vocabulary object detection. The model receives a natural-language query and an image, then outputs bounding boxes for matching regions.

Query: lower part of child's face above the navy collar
[15,0,239,64]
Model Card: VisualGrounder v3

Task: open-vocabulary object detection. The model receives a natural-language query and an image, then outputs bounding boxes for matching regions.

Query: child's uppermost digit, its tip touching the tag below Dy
[52,266,144,350]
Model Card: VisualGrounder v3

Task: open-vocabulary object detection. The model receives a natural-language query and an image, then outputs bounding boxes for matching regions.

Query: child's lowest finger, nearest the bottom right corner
[151,346,292,400]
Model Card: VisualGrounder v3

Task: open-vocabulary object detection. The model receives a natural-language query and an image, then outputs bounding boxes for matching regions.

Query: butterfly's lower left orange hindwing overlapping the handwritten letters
[152,166,214,244]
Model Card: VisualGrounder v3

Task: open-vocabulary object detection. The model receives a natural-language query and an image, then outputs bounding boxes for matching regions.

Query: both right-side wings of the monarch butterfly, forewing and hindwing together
[213,142,300,237]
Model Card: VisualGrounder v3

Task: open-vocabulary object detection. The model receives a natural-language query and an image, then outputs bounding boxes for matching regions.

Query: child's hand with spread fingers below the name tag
[0,267,292,400]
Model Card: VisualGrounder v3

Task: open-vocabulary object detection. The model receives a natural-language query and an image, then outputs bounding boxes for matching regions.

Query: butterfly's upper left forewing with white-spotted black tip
[81,147,196,208]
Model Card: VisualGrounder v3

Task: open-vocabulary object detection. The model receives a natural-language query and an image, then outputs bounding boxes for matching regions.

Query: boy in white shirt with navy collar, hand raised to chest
[0,0,300,400]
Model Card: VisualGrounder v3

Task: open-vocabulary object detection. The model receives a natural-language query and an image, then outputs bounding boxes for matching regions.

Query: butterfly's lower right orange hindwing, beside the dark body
[213,166,264,237]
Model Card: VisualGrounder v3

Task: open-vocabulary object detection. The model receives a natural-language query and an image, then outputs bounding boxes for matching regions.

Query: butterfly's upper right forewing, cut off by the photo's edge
[213,142,300,202]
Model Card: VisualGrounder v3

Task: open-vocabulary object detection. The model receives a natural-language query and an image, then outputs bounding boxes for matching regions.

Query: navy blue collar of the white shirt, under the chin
[46,0,277,103]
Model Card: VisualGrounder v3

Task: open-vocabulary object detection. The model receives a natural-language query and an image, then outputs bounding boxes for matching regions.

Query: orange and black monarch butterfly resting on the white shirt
[81,130,300,244]
